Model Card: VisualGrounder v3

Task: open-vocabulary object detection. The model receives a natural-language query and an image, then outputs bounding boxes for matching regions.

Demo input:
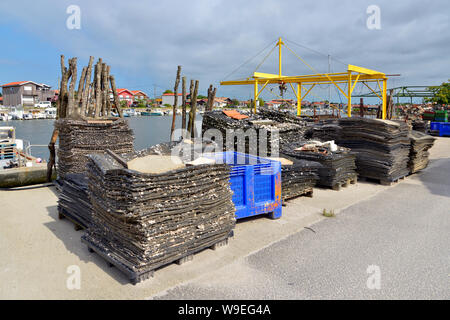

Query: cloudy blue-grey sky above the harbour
[0,0,450,101]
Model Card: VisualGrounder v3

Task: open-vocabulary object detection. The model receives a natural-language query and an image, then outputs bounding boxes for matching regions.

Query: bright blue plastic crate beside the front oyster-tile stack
[203,151,282,219]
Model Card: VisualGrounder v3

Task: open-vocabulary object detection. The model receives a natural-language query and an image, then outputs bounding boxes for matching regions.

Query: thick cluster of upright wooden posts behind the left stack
[57,55,123,119]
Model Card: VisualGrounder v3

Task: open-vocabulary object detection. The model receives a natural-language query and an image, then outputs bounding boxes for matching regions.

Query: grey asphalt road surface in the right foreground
[153,158,450,299]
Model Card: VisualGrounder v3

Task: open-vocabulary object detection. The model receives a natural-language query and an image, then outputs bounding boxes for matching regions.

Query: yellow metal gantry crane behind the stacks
[220,38,388,119]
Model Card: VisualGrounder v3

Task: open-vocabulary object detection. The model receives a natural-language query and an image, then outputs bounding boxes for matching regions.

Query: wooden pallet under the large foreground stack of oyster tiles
[81,231,234,285]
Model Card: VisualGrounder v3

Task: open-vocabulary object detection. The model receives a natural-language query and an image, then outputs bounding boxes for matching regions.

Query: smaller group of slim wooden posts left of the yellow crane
[170,66,199,139]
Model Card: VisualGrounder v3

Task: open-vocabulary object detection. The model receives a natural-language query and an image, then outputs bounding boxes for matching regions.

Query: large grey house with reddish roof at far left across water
[2,81,54,107]
